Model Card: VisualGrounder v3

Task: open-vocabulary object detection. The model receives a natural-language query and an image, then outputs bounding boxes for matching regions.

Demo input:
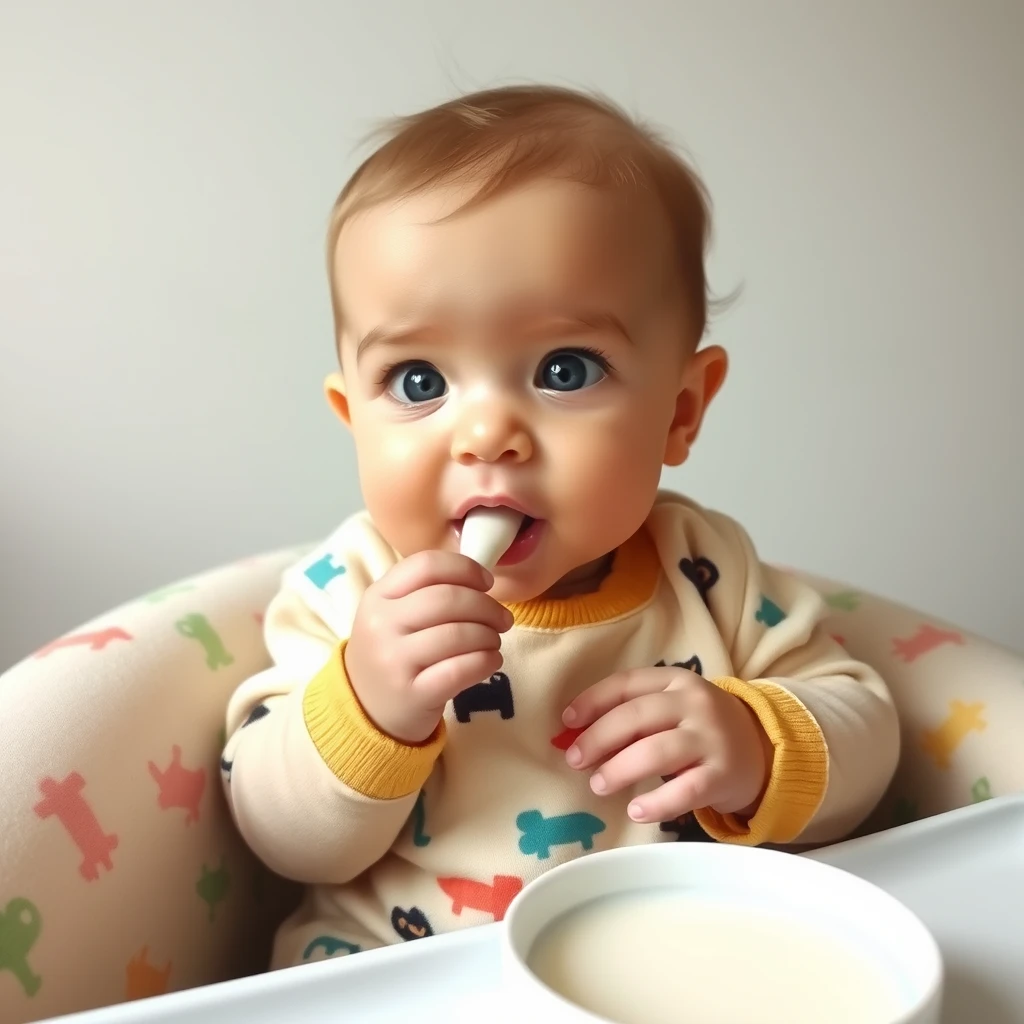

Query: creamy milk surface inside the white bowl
[526,889,901,1024]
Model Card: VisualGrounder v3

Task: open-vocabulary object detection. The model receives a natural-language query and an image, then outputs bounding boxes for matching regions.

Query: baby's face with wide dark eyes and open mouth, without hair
[329,174,724,602]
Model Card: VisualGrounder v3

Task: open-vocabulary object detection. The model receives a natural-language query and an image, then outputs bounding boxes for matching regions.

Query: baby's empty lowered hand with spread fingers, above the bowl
[562,667,772,822]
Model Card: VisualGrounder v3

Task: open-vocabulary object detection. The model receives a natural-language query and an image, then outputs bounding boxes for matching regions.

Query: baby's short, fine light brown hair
[327,85,712,346]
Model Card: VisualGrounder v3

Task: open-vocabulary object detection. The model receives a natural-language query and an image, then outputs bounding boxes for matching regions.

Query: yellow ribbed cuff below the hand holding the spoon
[302,643,445,800]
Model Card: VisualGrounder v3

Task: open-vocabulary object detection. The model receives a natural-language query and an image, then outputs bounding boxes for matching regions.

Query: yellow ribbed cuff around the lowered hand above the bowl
[694,678,828,846]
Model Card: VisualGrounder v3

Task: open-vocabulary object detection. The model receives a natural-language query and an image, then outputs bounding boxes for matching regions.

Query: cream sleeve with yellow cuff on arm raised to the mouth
[222,565,443,884]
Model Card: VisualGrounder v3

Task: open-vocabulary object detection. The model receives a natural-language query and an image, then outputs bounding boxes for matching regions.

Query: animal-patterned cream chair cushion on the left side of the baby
[0,551,307,1024]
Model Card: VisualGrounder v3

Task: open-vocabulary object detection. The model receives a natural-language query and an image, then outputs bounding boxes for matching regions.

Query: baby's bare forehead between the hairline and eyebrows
[335,179,672,339]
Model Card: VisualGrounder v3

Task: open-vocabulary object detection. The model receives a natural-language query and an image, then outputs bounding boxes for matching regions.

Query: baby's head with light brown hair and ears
[327,87,726,602]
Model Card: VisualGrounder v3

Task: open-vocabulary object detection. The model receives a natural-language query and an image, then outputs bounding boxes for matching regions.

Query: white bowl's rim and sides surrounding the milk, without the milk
[501,843,944,1024]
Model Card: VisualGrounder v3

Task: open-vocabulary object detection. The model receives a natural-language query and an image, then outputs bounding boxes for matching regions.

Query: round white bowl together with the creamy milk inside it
[503,844,942,1024]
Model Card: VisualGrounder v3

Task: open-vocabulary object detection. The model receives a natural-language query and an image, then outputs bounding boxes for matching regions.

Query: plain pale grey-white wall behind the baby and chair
[0,0,1024,669]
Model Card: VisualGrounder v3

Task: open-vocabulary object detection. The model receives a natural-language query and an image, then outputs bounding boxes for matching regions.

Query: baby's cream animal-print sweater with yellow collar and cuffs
[223,494,899,948]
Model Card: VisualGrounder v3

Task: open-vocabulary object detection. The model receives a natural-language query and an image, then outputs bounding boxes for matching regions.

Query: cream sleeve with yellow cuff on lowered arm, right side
[698,516,900,844]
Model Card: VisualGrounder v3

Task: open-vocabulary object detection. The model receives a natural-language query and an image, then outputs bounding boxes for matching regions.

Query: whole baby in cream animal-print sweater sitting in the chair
[224,81,899,967]
